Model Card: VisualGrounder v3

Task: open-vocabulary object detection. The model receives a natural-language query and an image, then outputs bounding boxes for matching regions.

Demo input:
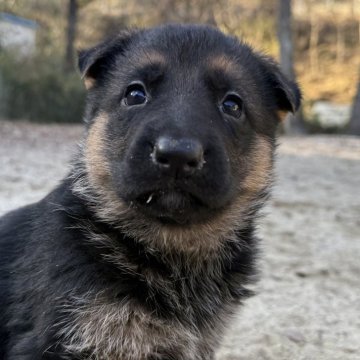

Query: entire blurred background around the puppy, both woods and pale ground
[0,0,360,360]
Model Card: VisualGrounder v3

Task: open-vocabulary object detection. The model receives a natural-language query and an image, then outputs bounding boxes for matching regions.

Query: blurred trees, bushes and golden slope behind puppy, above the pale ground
[0,0,360,135]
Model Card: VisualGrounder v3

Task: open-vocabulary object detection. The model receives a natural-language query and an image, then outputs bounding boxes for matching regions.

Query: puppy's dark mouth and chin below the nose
[135,190,214,226]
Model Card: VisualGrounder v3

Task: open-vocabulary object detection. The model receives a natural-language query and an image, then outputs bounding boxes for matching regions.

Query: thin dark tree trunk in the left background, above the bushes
[65,0,78,72]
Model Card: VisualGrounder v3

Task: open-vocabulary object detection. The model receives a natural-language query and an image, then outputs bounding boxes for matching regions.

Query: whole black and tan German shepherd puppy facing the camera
[0,25,300,360]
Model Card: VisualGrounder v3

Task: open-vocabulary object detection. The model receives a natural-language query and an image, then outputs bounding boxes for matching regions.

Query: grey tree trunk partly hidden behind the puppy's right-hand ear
[278,0,305,134]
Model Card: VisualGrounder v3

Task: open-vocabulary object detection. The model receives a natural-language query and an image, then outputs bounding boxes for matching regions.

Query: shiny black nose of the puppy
[151,137,204,175]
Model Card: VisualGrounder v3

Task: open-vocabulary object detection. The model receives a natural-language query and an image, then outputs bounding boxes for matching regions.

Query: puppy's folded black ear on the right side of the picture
[262,58,301,119]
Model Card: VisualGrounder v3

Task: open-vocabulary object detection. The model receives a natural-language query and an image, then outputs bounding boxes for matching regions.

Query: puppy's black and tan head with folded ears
[79,25,300,250]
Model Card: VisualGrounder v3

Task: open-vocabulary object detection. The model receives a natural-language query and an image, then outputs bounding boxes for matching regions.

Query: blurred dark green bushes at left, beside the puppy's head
[0,53,85,122]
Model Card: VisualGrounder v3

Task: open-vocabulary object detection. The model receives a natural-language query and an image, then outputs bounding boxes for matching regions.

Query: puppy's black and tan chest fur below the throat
[58,225,252,360]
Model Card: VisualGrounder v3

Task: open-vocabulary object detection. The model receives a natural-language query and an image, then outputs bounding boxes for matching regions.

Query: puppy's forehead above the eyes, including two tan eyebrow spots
[116,26,257,90]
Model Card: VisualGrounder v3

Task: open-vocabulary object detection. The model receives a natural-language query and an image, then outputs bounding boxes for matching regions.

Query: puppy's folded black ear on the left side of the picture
[78,30,138,90]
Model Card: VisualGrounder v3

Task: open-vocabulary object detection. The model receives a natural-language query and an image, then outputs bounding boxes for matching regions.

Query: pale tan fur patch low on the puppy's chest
[59,293,203,360]
